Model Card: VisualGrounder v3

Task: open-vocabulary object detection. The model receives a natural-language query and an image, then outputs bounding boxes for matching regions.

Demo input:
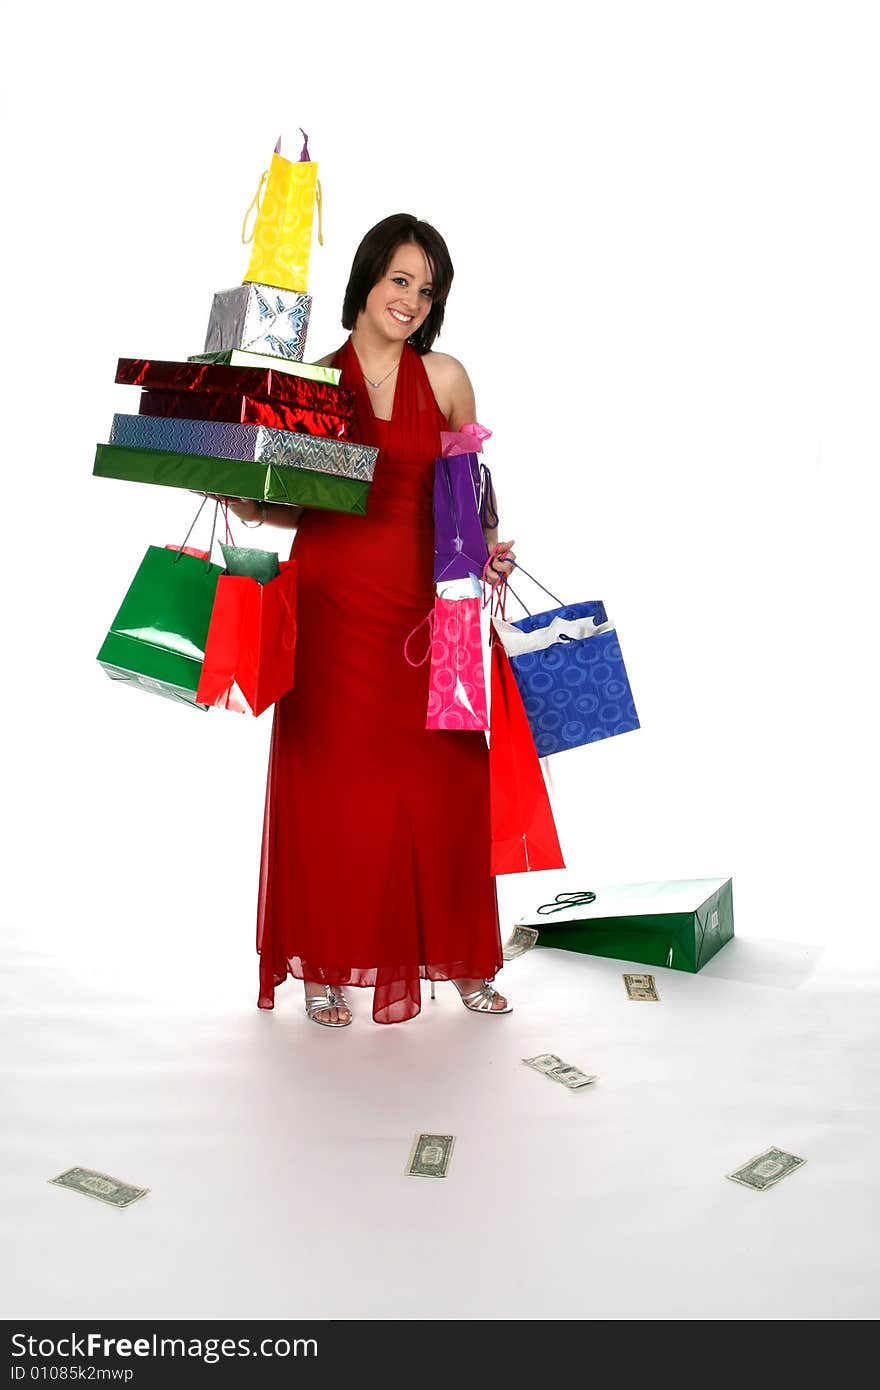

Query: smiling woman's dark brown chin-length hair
[342,213,455,354]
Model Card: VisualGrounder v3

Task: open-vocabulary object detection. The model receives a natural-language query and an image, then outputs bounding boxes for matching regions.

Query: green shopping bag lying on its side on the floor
[520,878,734,974]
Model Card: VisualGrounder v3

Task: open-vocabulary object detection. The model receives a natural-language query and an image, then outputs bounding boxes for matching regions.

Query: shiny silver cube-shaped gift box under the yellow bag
[204,285,311,361]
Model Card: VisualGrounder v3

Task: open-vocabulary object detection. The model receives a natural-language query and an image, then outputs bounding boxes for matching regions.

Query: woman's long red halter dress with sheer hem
[257,339,502,1023]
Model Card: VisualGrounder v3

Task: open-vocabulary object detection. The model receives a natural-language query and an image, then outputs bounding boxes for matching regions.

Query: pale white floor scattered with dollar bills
[0,929,880,1319]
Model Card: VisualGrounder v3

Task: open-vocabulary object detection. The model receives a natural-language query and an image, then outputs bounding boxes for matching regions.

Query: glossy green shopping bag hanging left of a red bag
[97,545,222,709]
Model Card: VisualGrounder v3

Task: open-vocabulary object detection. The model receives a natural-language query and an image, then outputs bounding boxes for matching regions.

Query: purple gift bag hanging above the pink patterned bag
[434,453,491,584]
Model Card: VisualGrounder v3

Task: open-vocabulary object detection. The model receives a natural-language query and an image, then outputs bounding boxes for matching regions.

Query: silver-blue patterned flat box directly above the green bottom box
[110,414,378,482]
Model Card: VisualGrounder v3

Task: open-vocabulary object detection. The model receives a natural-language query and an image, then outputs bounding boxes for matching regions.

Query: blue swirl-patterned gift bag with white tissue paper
[500,581,639,758]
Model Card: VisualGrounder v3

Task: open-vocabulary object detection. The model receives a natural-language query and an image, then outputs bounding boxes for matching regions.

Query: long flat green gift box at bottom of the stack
[92,443,370,516]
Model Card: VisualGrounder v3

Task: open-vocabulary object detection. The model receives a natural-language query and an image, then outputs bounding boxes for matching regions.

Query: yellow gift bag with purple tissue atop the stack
[242,131,324,295]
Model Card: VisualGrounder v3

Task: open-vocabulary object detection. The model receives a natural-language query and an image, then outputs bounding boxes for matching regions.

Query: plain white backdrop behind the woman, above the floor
[0,0,880,998]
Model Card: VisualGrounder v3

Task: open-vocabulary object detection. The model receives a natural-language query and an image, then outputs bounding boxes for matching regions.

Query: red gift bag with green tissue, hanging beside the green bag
[196,560,296,714]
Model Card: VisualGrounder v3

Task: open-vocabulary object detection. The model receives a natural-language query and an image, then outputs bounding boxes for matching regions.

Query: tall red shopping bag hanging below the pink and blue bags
[489,637,566,874]
